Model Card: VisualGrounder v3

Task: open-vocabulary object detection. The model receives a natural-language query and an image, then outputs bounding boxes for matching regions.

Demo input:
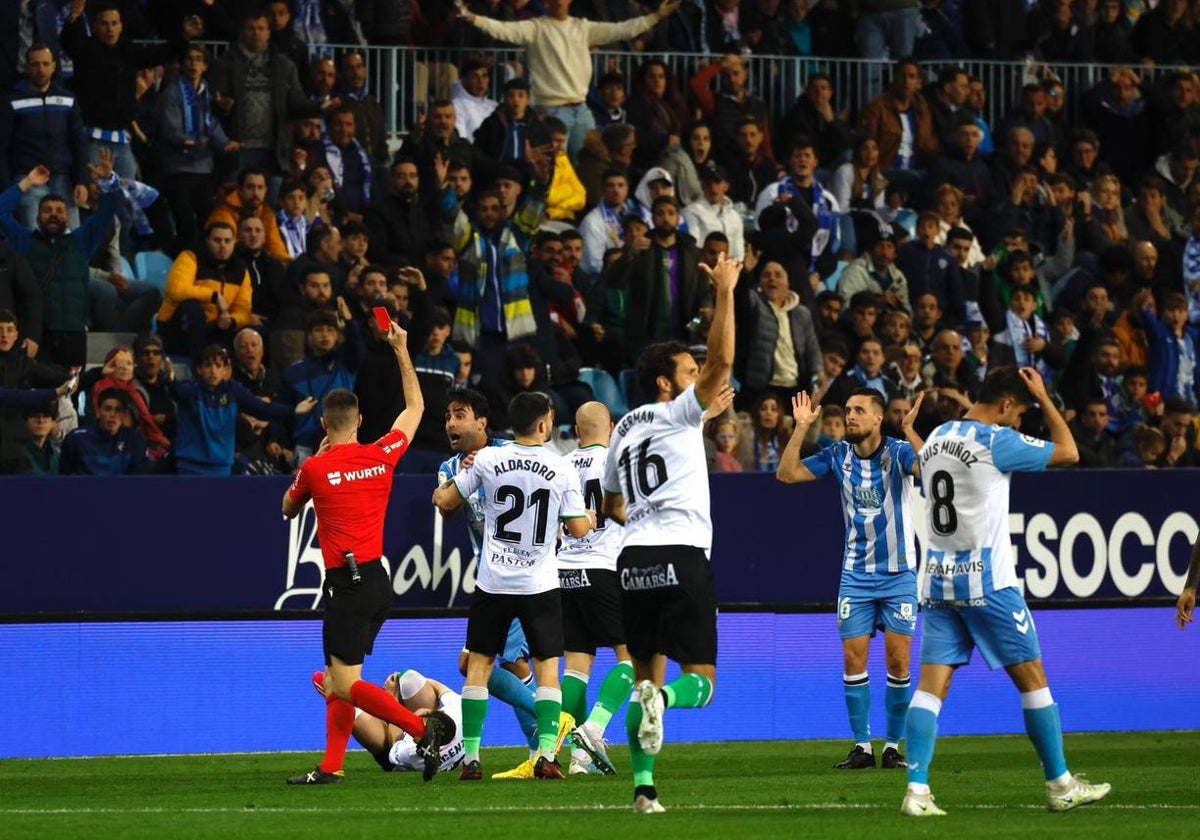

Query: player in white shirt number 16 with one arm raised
[604,254,742,814]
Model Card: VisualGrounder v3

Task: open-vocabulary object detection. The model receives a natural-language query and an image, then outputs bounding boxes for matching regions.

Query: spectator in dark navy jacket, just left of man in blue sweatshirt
[59,388,154,475]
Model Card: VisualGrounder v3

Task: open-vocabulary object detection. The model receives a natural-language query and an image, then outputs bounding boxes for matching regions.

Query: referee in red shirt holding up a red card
[283,323,457,785]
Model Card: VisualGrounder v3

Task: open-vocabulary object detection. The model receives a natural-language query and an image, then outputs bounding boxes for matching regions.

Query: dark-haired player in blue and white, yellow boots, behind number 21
[438,388,575,779]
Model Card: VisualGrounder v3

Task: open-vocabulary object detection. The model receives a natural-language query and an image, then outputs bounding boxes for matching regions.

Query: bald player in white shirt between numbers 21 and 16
[558,402,634,775]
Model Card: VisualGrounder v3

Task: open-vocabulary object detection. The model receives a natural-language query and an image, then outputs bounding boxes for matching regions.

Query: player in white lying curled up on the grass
[312,668,462,773]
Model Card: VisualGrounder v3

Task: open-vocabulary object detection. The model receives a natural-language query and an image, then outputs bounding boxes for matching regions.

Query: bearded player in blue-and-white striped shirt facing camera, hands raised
[775,388,919,770]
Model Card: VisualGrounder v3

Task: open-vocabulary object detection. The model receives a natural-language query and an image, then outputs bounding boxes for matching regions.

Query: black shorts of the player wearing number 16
[617,546,716,665]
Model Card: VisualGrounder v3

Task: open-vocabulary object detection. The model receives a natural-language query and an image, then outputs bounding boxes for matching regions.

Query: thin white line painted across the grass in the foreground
[0,802,1200,816]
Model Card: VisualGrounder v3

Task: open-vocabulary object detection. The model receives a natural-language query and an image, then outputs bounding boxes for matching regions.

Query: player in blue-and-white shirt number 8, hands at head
[900,367,1110,816]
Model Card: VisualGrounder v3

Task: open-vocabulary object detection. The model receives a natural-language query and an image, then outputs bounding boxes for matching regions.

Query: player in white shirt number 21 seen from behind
[433,391,595,781]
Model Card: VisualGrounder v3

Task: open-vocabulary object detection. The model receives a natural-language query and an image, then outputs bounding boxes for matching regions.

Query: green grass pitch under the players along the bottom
[0,721,1200,840]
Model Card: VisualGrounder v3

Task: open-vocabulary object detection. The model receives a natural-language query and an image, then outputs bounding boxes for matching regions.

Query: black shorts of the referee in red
[322,560,392,665]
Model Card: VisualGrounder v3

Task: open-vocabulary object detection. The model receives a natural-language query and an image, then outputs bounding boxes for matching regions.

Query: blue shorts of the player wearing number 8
[920,587,1042,671]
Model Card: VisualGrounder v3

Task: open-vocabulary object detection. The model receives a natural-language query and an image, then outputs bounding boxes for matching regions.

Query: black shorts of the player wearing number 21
[467,587,563,659]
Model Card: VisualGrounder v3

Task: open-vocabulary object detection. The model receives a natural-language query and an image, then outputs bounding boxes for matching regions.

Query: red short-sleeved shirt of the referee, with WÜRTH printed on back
[288,431,408,569]
